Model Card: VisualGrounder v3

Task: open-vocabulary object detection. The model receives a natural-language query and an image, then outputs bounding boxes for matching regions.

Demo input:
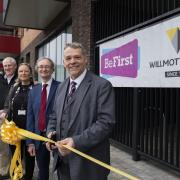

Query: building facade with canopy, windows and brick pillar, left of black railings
[4,0,95,81]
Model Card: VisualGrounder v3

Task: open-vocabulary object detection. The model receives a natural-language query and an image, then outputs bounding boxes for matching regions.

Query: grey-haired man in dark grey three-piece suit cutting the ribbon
[46,43,115,180]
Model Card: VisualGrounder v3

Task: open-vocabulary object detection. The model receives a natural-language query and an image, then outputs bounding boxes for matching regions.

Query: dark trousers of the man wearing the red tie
[36,142,50,180]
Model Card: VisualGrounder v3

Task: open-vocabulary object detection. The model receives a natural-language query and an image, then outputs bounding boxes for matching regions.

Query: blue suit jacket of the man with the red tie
[26,80,59,148]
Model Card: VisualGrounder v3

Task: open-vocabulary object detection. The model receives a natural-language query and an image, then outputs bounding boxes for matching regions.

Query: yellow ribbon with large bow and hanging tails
[1,119,138,180]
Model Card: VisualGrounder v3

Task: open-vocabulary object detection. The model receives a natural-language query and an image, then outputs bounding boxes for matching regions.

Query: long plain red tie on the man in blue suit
[38,84,47,132]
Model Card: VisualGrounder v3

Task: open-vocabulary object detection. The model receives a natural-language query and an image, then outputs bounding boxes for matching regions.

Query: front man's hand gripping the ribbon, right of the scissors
[55,138,75,156]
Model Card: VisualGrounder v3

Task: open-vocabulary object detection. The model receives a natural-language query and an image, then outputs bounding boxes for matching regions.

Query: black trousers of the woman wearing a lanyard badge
[10,141,35,180]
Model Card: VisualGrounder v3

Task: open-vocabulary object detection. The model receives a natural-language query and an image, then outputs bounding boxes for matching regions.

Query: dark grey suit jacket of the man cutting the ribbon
[47,71,115,180]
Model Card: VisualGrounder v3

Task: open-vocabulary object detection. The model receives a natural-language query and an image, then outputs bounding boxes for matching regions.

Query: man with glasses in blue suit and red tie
[26,57,59,180]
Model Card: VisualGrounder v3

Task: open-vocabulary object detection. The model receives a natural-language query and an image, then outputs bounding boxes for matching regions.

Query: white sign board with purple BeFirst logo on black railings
[100,16,180,87]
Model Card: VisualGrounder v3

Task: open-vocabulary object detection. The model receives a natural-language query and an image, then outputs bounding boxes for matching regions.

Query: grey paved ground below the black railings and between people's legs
[5,146,180,180]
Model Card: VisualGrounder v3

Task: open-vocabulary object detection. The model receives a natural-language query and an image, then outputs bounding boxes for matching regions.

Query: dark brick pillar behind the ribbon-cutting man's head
[71,0,95,71]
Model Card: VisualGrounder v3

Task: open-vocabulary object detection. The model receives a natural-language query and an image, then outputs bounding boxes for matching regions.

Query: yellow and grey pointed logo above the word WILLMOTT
[166,27,180,53]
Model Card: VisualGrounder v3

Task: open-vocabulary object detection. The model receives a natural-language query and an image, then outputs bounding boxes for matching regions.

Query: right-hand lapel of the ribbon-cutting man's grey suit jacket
[68,73,91,130]
